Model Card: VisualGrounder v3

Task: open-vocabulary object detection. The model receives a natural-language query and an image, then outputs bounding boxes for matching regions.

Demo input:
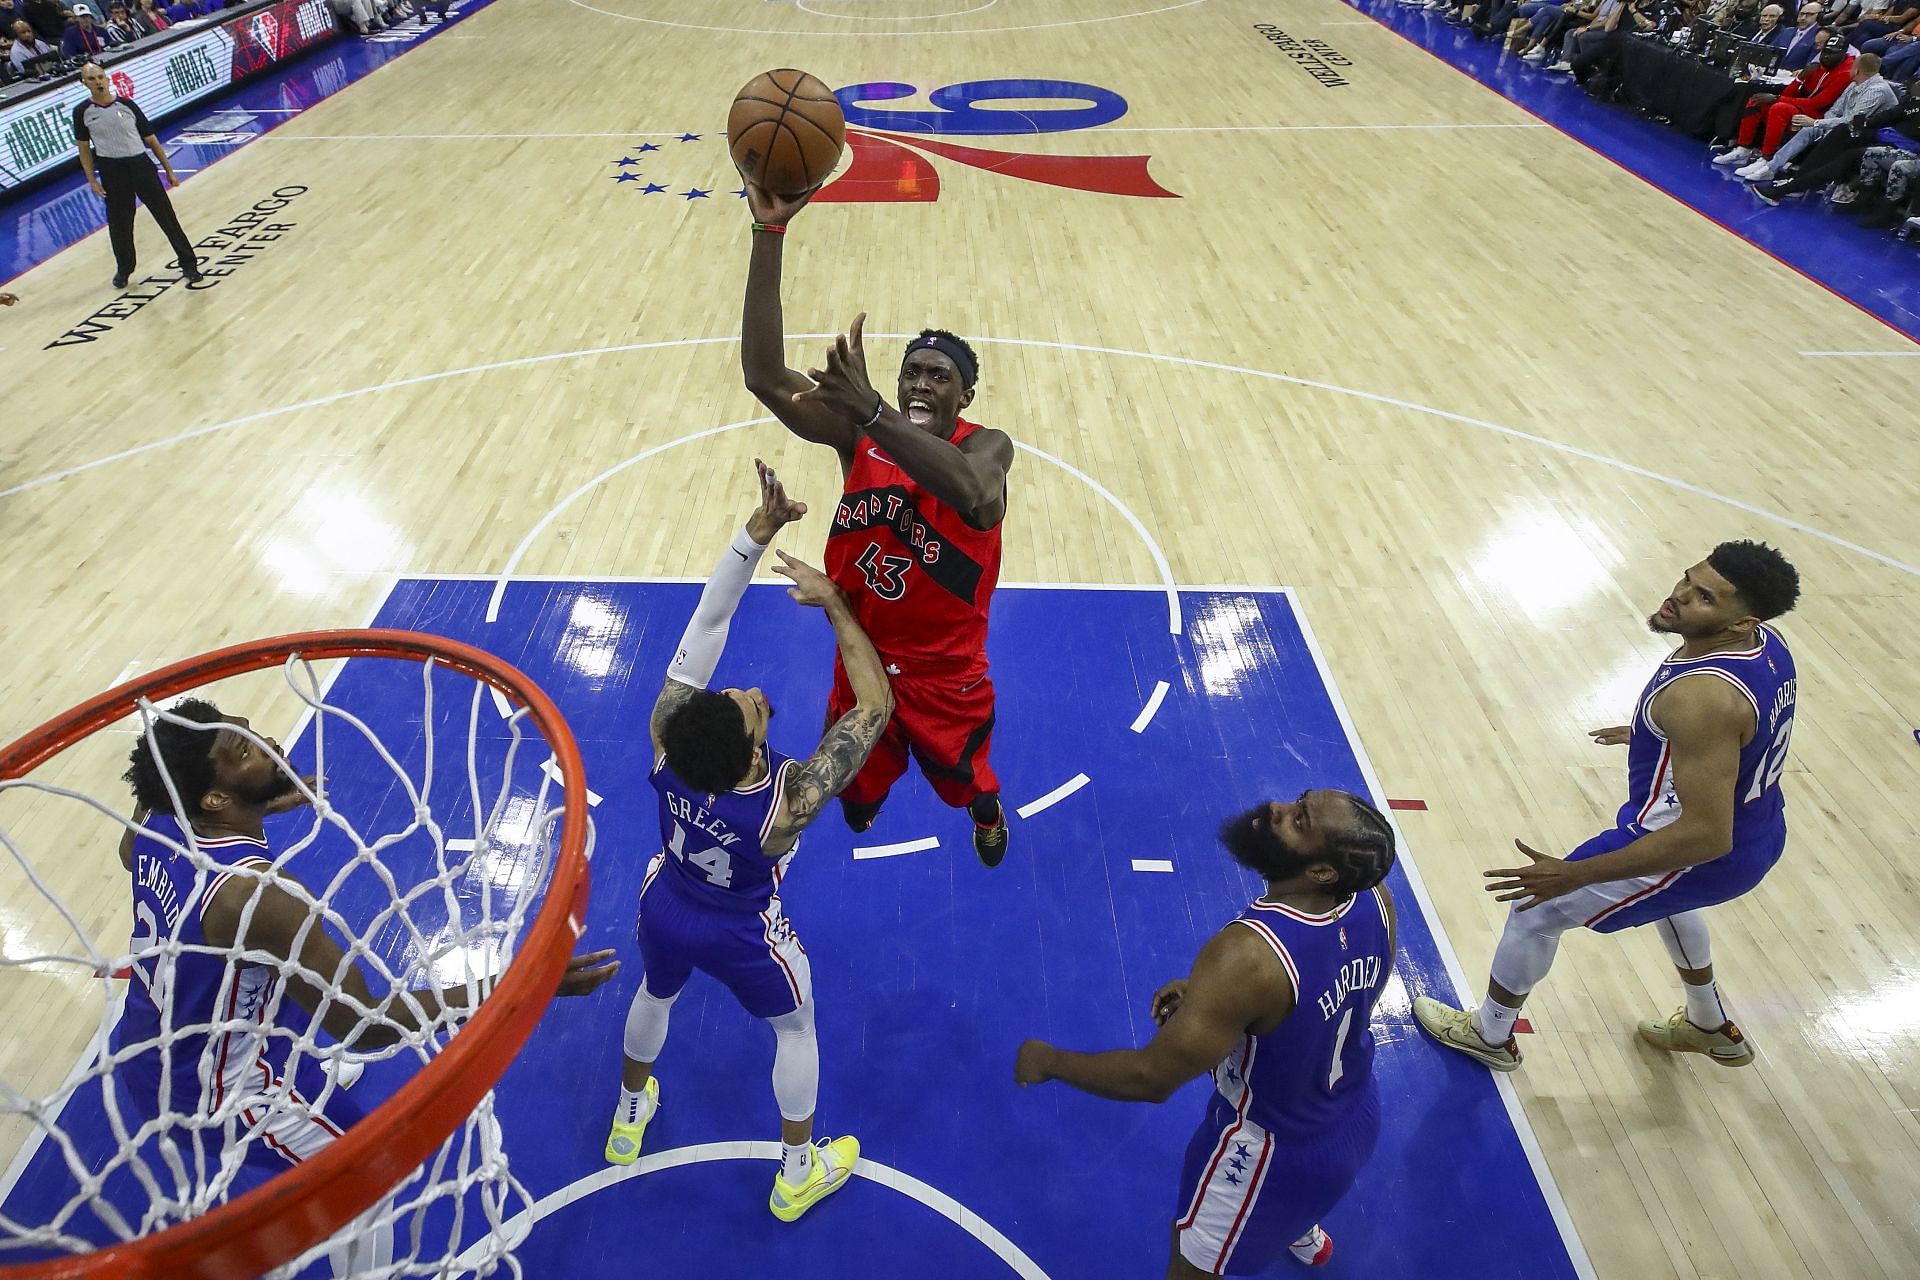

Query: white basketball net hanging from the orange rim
[0,654,586,1280]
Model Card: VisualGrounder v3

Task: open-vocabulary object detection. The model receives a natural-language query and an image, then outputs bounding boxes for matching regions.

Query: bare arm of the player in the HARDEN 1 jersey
[1014,925,1296,1102]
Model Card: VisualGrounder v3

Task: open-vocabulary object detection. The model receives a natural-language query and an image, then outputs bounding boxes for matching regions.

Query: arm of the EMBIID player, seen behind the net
[200,871,620,1052]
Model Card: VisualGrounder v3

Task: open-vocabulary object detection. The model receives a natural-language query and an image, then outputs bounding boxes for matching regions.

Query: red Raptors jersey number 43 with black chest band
[828,418,1000,662]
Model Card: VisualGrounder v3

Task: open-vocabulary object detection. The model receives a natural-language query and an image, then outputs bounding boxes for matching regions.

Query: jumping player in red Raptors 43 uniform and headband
[739,186,1014,867]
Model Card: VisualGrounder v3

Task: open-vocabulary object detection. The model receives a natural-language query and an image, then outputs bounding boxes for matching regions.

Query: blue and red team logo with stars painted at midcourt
[611,81,1179,203]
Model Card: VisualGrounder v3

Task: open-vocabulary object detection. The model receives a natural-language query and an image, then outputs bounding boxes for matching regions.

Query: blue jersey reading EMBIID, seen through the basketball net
[111,814,278,1115]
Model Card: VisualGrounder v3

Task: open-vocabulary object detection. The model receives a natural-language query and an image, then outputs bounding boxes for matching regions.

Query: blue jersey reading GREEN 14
[653,745,799,913]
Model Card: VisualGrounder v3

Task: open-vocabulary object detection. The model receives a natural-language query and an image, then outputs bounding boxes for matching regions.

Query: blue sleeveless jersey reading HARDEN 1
[1213,889,1394,1138]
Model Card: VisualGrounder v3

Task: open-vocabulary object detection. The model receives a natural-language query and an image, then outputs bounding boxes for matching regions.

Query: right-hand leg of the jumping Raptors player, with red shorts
[893,672,1008,867]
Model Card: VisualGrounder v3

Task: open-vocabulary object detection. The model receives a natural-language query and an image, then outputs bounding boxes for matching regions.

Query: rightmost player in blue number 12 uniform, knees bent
[1413,541,1799,1071]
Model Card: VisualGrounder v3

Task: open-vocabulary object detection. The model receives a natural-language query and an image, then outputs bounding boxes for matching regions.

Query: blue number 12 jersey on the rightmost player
[1617,628,1795,852]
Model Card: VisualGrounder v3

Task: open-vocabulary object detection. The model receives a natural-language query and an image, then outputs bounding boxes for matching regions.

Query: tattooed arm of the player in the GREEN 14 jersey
[764,551,893,858]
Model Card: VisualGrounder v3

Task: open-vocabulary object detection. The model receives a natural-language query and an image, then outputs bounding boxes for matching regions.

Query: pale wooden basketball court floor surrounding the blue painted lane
[0,0,1920,1280]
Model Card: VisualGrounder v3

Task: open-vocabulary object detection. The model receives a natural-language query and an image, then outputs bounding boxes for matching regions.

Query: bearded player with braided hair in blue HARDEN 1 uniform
[1014,791,1396,1280]
